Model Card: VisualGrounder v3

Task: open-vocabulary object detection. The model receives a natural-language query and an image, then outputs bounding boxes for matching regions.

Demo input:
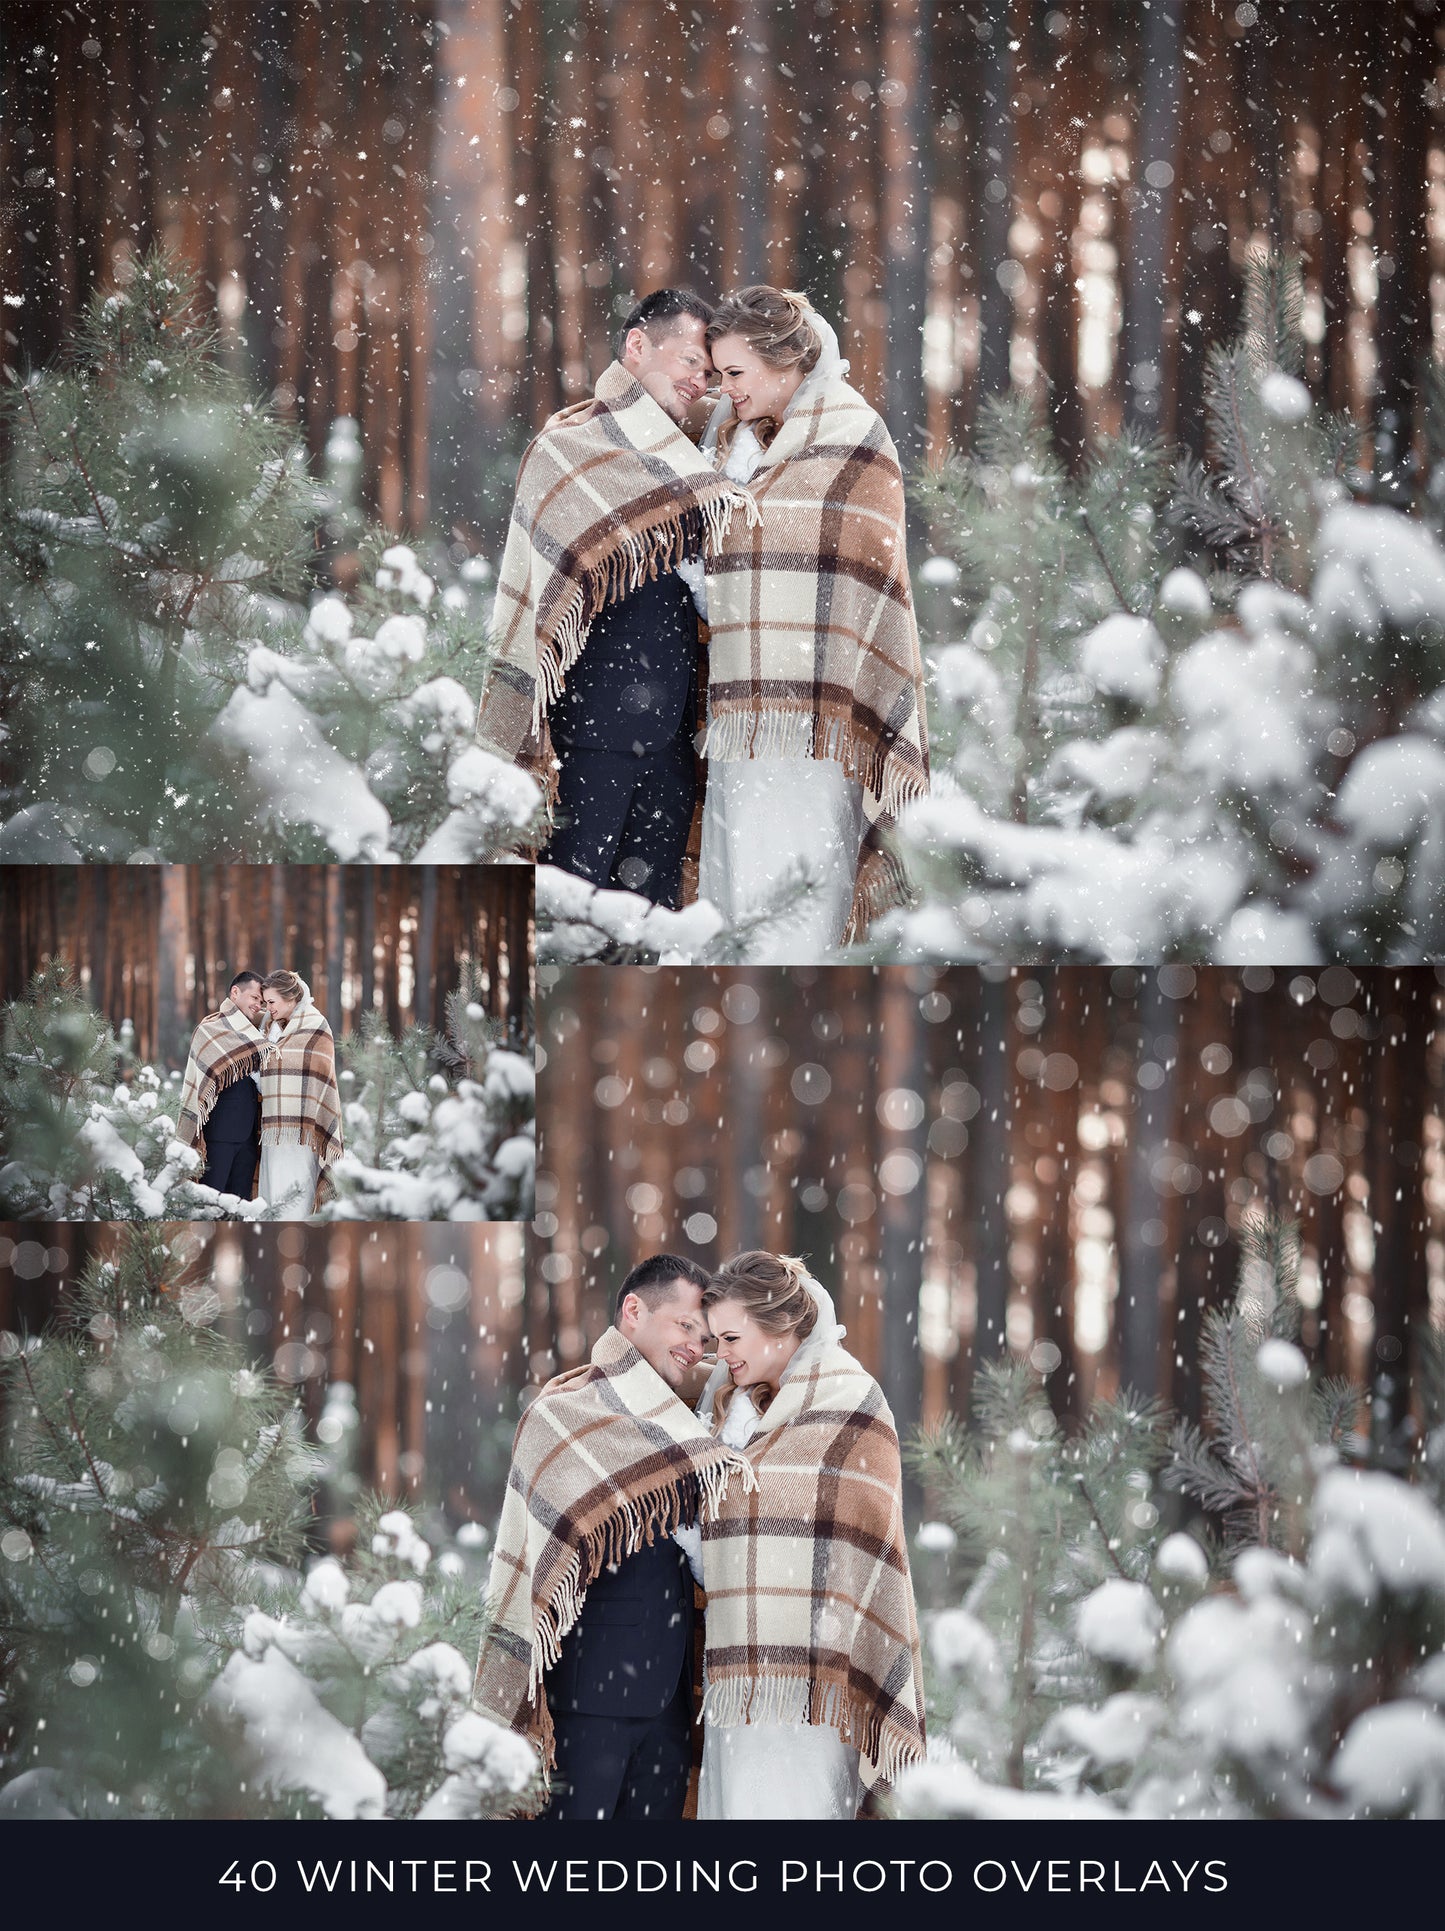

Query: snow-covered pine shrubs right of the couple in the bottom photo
[896,1224,1445,1817]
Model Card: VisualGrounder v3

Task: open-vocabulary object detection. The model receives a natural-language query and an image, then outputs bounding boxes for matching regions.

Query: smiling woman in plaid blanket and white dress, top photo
[690,286,929,966]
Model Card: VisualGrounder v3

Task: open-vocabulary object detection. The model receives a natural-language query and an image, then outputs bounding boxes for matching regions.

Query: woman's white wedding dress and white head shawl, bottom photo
[674,1286,864,1823]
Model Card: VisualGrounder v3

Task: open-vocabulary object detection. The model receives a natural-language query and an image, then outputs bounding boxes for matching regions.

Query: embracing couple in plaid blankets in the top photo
[477,284,929,964]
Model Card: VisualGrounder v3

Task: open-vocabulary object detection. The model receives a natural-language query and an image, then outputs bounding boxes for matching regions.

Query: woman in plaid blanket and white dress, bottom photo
[674,1253,923,1819]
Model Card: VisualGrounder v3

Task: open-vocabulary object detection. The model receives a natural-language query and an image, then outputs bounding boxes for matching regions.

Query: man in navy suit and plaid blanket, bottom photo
[477,1253,726,1819]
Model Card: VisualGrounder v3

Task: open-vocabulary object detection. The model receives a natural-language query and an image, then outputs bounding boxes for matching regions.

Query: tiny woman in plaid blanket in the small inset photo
[257,971,342,1220]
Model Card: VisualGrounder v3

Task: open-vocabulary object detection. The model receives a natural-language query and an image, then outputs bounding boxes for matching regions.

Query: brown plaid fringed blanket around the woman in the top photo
[703,380,929,929]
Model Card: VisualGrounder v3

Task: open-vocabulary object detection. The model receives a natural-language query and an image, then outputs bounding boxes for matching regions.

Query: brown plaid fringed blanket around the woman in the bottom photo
[703,1346,923,1782]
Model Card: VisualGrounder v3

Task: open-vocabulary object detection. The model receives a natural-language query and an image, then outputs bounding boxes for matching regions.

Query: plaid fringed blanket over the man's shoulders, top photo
[477,363,757,801]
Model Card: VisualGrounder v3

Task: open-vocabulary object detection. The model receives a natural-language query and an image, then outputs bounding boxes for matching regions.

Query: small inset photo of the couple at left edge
[0,865,535,1220]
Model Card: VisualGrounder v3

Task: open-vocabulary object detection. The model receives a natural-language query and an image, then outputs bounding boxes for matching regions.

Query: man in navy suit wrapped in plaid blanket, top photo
[477,288,757,906]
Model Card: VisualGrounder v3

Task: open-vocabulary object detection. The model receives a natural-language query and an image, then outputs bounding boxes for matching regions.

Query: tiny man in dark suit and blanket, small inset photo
[176,971,267,1201]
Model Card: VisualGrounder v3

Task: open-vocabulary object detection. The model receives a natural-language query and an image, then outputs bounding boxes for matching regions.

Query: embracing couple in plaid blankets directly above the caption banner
[477,1253,923,1819]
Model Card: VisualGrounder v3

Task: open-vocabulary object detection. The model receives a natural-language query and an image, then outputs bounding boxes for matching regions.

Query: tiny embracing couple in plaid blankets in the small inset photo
[176,971,342,1220]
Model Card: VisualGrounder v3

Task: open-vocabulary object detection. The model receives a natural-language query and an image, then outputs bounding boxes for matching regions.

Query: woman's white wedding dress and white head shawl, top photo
[690,315,864,966]
